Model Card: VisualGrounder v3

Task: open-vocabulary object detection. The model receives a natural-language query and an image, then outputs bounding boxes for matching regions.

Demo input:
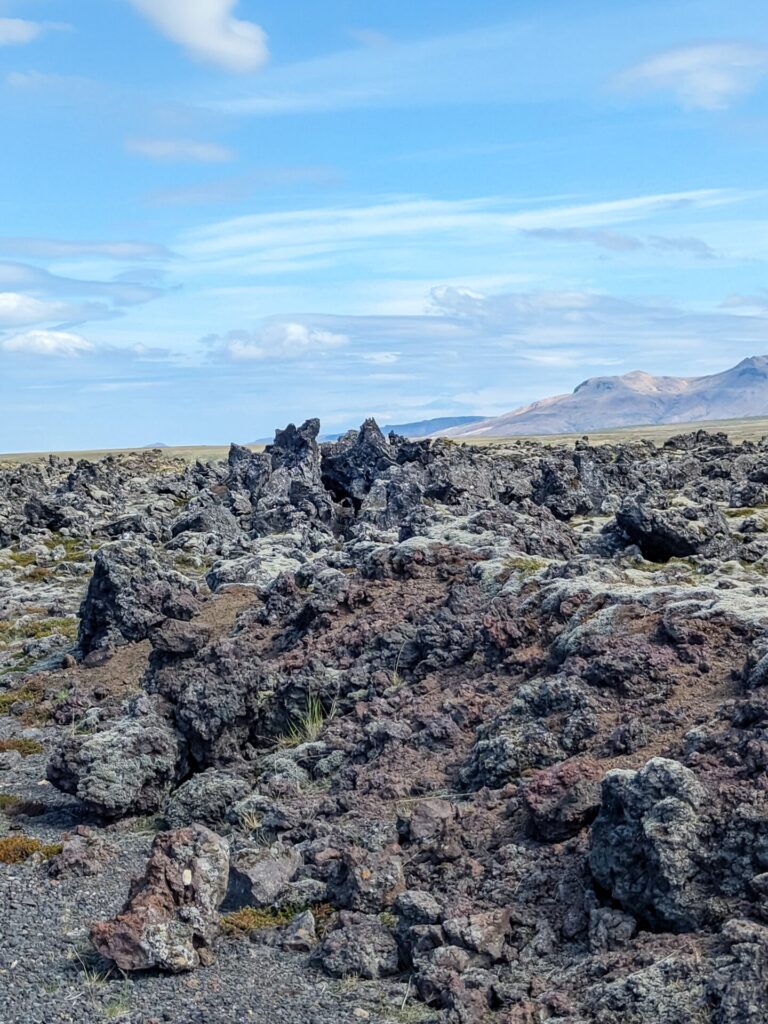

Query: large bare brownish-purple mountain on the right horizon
[440,355,768,437]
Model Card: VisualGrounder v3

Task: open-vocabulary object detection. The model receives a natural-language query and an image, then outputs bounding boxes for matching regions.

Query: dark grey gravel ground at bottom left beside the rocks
[0,756,433,1024]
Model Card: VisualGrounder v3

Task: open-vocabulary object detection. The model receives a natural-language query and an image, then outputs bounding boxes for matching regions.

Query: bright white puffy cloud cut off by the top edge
[130,0,268,73]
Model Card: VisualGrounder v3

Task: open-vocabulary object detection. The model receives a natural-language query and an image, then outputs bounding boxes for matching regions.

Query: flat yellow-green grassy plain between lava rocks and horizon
[0,416,768,465]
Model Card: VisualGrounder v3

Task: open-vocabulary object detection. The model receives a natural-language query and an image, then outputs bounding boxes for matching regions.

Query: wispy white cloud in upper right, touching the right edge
[615,43,768,111]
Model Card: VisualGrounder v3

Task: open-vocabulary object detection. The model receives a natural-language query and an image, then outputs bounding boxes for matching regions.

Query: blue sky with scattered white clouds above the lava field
[0,0,768,452]
